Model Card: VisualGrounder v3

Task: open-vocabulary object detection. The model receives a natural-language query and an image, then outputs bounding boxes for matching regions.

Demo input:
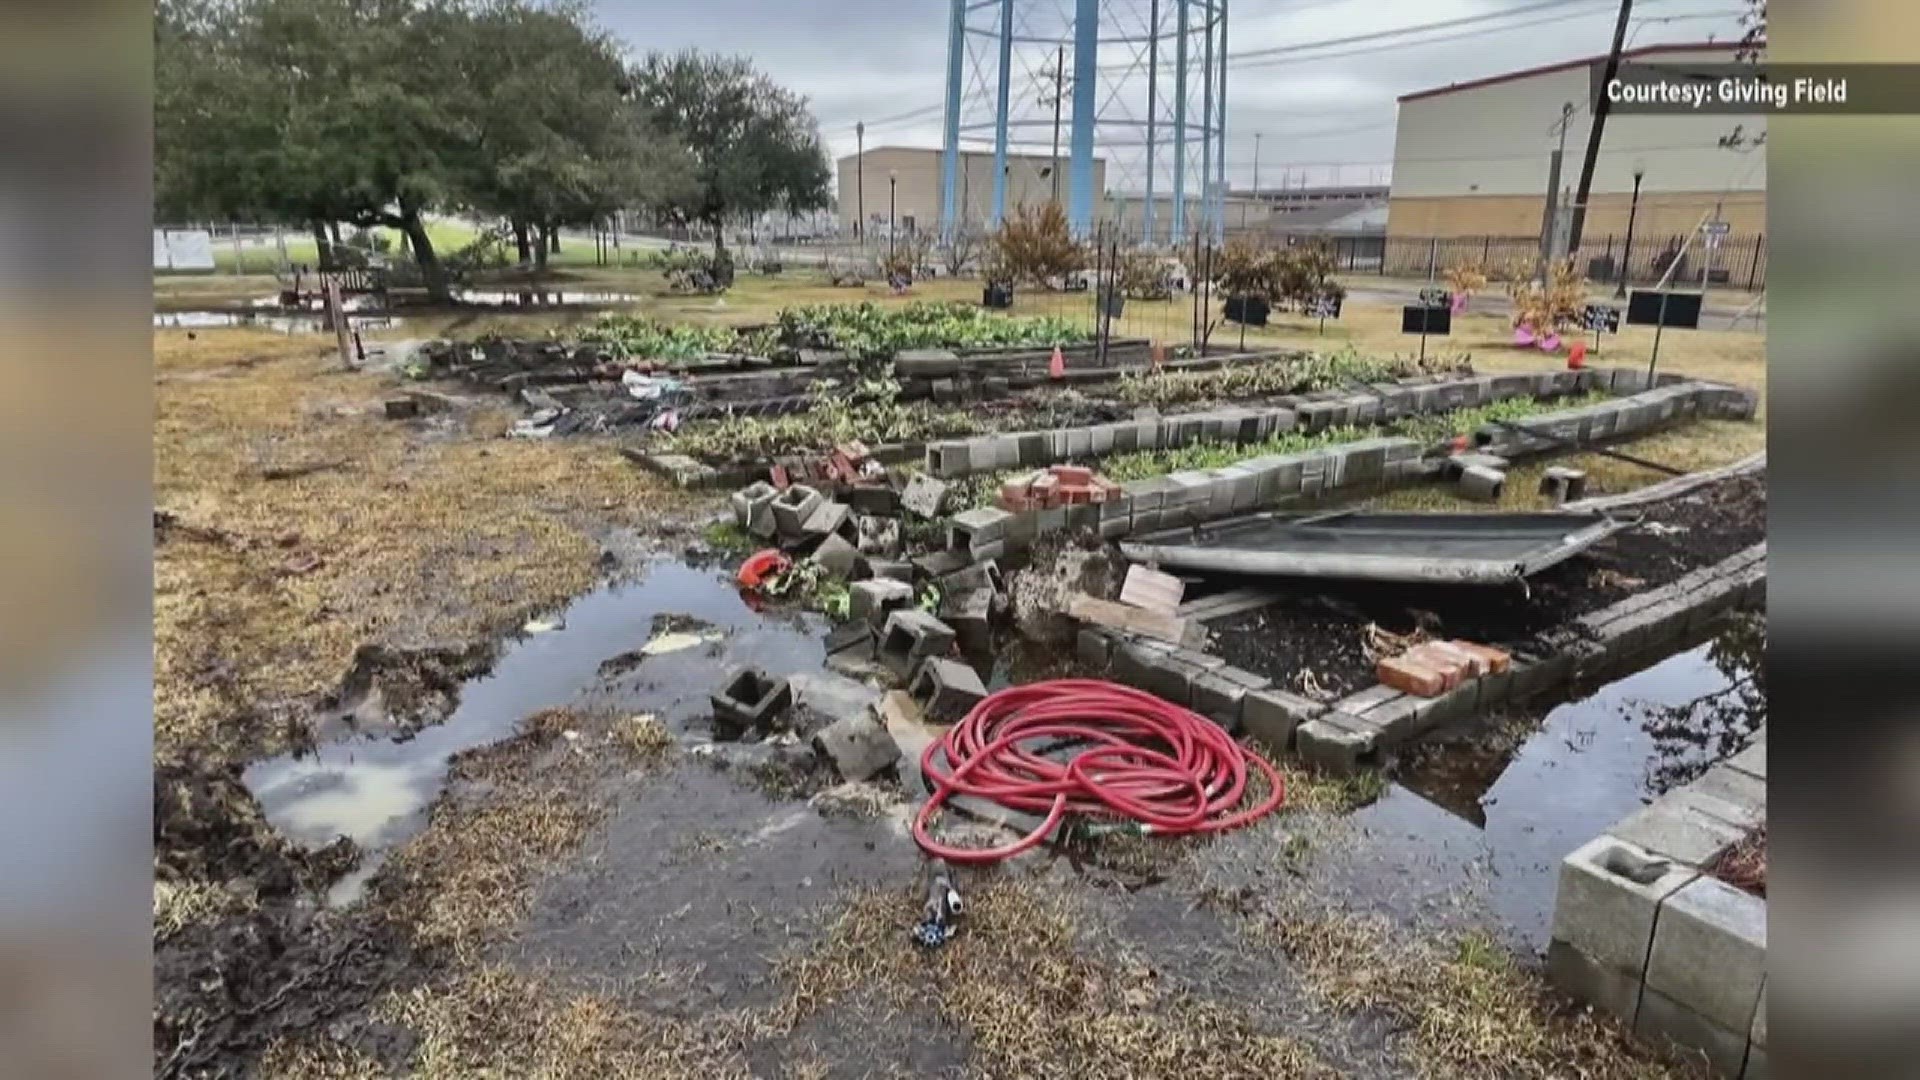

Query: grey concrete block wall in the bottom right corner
[1548,728,1766,1080]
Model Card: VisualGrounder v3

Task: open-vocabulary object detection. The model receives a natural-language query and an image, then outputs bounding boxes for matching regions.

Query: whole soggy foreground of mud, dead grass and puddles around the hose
[154,322,1758,1078]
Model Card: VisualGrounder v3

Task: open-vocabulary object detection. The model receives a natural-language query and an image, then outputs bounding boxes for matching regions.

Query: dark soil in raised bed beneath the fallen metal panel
[1208,475,1766,696]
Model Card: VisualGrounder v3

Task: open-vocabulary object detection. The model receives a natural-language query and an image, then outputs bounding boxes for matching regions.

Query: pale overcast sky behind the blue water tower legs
[595,0,1741,186]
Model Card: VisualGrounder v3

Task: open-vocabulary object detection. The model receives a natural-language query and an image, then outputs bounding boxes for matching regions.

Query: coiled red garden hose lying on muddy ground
[914,678,1286,863]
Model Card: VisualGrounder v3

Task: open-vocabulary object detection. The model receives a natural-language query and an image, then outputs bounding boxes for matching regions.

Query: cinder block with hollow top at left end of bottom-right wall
[1553,834,1699,980]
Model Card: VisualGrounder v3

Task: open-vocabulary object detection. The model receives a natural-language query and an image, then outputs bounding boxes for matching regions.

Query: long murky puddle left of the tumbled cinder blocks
[246,563,824,901]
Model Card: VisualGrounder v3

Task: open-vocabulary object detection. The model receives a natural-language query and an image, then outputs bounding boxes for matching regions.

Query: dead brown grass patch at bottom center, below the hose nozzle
[768,878,1336,1078]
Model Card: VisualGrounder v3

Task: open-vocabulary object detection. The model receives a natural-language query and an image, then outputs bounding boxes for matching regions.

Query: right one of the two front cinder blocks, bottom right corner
[1647,876,1766,1022]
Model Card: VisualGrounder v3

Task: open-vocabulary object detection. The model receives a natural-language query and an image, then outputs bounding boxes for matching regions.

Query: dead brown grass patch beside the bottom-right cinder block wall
[1246,903,1690,1078]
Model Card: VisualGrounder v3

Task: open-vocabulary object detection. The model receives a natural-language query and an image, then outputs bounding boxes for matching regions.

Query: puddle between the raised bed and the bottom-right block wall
[1354,634,1759,949]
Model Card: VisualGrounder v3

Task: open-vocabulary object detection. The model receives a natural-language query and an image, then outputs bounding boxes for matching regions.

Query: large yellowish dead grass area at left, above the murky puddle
[154,331,698,757]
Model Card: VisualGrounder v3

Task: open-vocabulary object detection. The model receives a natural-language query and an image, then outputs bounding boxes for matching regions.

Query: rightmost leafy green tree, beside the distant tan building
[634,50,829,256]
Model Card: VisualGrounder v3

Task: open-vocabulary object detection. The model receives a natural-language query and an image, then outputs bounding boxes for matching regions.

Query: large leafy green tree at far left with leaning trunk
[156,0,476,300]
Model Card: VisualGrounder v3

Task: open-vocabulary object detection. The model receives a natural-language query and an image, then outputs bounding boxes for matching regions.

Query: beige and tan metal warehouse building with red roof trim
[1386,44,1766,247]
